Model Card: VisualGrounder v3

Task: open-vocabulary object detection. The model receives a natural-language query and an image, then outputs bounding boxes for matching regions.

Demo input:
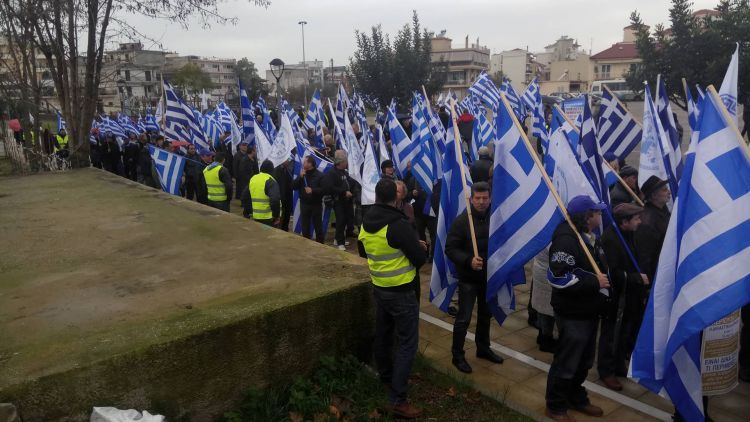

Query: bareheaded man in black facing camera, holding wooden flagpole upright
[445,182,503,374]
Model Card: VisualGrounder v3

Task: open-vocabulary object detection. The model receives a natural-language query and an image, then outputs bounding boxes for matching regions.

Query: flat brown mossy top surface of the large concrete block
[0,169,367,391]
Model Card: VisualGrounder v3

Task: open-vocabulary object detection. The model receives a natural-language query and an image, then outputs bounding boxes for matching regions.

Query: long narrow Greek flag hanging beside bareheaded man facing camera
[430,113,466,312]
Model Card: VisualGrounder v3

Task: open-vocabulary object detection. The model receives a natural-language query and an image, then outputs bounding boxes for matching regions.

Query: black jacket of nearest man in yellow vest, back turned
[357,204,427,290]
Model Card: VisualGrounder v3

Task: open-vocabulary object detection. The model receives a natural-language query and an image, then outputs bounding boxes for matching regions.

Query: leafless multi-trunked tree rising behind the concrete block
[0,0,270,167]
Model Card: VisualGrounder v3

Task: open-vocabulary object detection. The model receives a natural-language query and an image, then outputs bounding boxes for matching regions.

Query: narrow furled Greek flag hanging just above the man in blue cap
[578,99,609,204]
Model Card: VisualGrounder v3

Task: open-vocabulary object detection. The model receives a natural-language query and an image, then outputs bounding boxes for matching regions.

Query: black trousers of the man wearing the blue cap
[546,315,599,414]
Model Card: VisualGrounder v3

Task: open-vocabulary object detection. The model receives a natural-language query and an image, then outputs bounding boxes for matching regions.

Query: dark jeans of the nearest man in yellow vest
[373,287,419,405]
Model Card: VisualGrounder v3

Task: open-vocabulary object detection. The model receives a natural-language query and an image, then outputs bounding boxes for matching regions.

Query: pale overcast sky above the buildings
[126,0,718,71]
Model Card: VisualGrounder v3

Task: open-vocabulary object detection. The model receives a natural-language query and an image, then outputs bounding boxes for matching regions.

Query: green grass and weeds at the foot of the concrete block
[223,356,531,422]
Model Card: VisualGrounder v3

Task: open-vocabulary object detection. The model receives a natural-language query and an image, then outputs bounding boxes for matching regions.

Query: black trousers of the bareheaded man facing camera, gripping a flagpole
[451,281,492,358]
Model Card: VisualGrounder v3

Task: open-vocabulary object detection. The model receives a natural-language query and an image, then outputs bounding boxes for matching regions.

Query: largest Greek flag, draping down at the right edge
[628,87,750,421]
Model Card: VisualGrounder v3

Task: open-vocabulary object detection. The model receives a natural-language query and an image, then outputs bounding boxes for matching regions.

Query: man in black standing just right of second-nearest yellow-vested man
[292,155,325,243]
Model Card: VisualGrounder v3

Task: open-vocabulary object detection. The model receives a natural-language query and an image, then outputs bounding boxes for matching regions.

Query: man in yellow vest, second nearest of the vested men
[242,160,281,227]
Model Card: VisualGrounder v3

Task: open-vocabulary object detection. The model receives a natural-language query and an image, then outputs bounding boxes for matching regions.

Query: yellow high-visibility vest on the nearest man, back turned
[359,225,417,287]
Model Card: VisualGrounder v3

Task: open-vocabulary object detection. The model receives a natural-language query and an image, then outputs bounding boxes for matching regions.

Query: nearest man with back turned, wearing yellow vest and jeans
[358,179,427,418]
